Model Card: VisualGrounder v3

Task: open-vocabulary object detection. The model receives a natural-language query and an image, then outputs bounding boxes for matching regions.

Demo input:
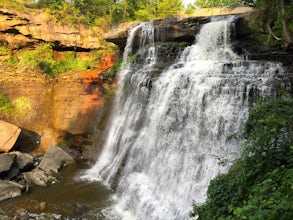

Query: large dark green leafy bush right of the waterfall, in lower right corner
[191,94,293,220]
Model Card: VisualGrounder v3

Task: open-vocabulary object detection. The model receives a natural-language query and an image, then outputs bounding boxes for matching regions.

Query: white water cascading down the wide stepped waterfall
[82,18,282,220]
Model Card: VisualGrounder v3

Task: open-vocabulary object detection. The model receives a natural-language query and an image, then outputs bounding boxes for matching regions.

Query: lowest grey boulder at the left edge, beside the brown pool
[0,180,23,202]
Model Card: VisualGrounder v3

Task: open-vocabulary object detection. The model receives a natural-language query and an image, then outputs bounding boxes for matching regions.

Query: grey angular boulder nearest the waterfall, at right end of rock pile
[39,146,74,173]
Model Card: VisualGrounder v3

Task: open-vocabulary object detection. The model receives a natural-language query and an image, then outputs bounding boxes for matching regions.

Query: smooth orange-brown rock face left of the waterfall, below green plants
[0,53,117,150]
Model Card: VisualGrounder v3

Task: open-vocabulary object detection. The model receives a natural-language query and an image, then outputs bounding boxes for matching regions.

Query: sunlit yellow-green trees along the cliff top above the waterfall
[12,0,183,27]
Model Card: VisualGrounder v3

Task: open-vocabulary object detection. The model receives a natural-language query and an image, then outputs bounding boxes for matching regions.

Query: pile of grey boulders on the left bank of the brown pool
[0,146,75,219]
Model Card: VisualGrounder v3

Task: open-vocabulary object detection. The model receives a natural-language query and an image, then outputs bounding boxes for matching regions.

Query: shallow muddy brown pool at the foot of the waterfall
[0,163,112,219]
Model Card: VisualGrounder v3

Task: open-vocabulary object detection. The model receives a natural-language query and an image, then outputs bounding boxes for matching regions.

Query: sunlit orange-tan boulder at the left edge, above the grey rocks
[0,120,21,152]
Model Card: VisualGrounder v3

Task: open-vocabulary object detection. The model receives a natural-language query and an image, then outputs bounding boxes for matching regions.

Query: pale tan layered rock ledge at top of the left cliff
[0,8,102,50]
